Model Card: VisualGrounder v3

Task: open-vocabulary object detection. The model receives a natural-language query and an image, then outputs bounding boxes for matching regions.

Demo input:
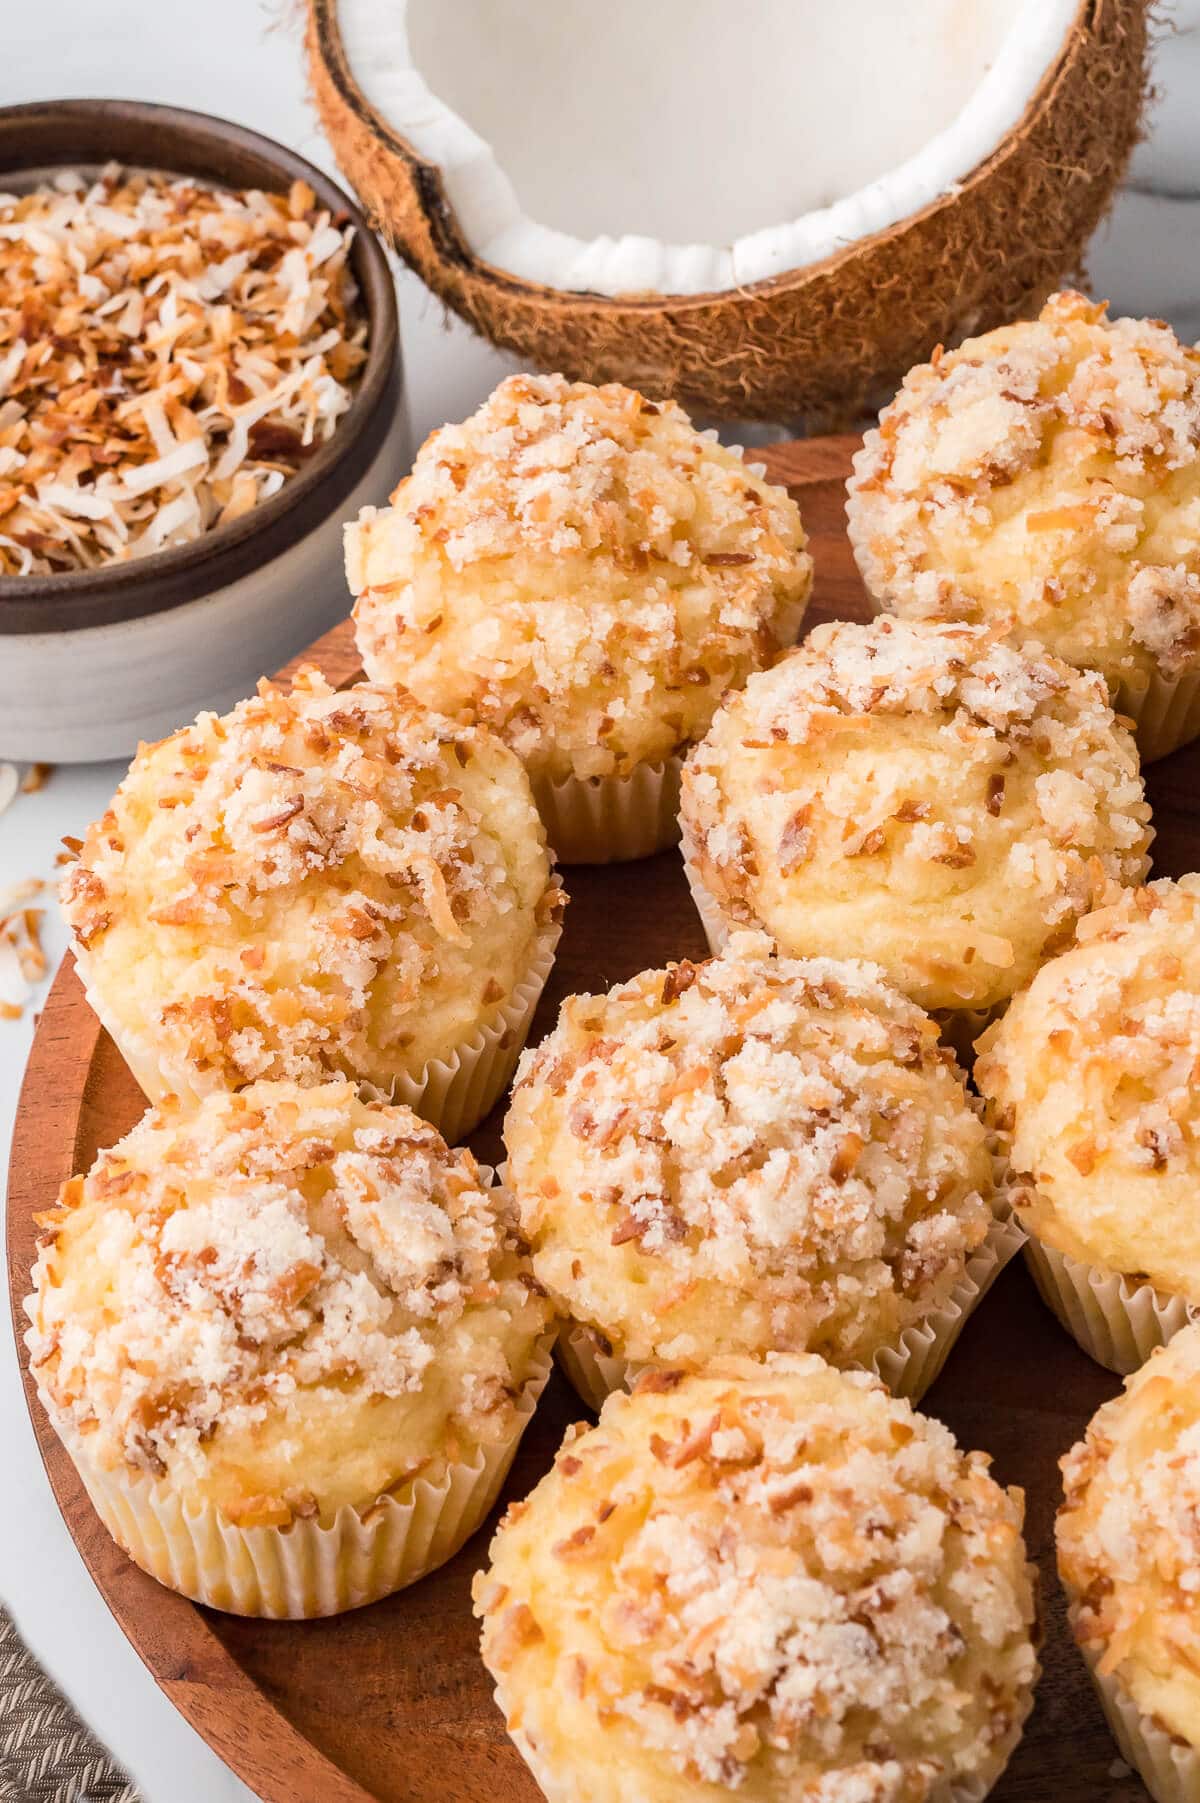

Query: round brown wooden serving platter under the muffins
[7,438,1200,1803]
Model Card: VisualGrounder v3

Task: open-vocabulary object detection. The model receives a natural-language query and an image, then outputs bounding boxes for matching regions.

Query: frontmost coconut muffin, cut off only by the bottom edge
[476,1354,1036,1803]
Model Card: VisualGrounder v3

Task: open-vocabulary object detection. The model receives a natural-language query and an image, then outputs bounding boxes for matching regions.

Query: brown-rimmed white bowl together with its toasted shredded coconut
[0,101,411,761]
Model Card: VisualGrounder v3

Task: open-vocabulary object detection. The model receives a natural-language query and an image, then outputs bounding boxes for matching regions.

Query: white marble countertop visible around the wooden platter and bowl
[0,0,1200,1803]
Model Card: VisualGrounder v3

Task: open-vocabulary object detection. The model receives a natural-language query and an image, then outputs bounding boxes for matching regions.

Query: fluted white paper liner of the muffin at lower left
[41,1336,553,1621]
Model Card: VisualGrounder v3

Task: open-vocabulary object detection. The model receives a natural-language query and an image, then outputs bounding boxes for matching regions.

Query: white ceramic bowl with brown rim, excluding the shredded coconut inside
[0,101,411,763]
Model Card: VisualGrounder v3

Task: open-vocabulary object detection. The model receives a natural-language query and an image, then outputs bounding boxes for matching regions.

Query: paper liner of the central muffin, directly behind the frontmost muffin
[557,1215,1025,1410]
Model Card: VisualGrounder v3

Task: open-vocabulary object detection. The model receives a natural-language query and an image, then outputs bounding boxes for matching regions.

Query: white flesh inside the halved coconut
[337,0,1079,296]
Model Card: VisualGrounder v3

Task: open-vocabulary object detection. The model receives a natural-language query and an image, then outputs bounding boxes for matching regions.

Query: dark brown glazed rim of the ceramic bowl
[0,99,402,636]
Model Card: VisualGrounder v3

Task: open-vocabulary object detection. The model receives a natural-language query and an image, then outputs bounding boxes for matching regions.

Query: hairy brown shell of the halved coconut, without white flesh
[308,0,1151,426]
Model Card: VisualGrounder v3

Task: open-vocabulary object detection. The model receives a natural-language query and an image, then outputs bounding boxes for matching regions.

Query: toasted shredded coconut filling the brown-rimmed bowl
[0,164,366,575]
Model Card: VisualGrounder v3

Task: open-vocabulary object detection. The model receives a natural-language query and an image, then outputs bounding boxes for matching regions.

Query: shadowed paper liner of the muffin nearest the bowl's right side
[533,757,683,864]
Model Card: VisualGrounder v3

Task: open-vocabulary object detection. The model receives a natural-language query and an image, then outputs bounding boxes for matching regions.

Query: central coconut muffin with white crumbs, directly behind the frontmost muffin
[505,932,1020,1406]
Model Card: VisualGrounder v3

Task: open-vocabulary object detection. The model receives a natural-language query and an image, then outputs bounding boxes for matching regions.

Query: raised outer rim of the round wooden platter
[5,435,861,1803]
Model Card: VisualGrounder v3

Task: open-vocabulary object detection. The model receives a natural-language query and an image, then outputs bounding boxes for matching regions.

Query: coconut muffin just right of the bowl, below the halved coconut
[346,375,813,860]
